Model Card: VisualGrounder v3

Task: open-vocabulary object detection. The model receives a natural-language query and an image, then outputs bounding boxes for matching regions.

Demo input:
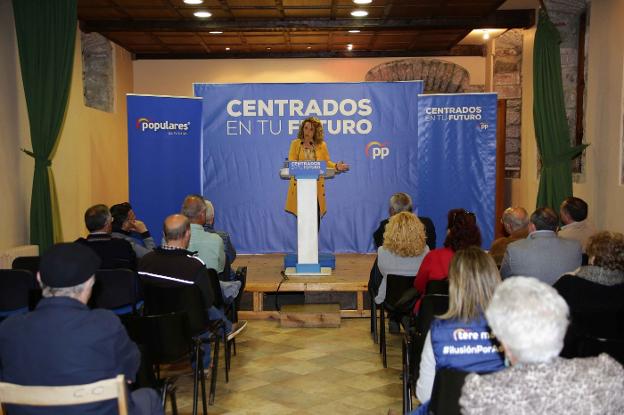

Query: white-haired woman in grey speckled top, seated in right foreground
[459,277,624,415]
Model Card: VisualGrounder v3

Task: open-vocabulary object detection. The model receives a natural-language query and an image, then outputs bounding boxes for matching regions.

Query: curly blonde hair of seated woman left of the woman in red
[383,212,427,257]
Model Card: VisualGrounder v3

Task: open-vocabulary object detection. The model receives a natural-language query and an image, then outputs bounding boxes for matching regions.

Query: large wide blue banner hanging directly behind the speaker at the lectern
[195,81,422,253]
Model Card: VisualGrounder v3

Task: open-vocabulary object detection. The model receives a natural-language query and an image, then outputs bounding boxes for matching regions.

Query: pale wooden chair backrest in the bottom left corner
[0,375,128,415]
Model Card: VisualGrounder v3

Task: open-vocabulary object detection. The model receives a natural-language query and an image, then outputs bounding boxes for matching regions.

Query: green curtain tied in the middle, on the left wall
[13,0,77,252]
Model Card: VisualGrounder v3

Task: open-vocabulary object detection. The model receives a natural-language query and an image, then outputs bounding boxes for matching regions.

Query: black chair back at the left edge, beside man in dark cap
[0,269,38,321]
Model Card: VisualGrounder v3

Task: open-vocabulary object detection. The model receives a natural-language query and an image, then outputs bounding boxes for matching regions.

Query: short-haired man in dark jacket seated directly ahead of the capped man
[76,205,136,270]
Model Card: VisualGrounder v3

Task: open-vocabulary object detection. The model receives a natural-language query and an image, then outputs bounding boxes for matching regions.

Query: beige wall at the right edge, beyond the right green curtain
[574,0,624,232]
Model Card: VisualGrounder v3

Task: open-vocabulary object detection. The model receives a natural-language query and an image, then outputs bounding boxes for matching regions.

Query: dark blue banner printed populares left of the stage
[127,95,202,243]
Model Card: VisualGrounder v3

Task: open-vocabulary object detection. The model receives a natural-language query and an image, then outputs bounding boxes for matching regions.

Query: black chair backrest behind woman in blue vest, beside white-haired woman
[429,369,469,415]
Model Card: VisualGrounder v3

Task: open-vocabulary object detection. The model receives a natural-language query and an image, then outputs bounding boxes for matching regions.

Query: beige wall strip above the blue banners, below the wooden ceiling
[134,56,485,96]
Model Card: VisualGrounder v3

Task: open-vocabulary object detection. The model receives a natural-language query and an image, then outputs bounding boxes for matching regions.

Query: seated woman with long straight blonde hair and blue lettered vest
[415,246,505,414]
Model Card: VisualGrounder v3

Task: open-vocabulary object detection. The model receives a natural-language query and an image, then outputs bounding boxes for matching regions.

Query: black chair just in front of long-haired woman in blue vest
[402,294,449,404]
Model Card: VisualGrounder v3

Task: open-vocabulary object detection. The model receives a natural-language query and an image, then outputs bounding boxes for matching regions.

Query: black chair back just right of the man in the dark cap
[89,268,141,315]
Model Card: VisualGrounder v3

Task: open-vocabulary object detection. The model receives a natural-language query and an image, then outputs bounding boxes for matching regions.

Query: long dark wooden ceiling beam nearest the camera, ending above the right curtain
[81,9,535,32]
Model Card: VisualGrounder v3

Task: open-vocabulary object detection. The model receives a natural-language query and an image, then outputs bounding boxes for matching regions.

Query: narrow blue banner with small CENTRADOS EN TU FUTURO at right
[416,94,496,248]
